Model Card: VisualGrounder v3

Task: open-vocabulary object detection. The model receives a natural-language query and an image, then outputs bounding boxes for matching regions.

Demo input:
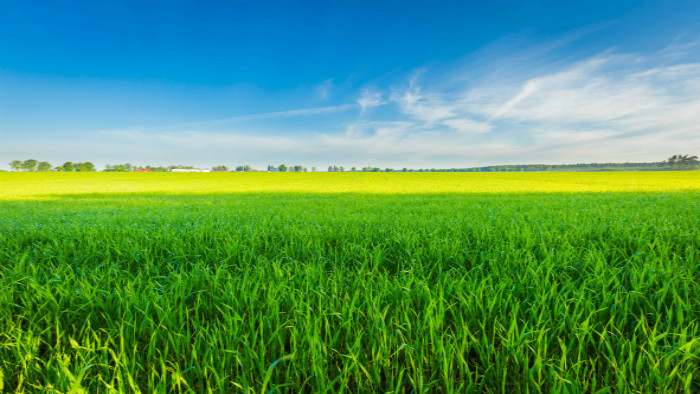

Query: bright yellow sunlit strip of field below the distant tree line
[0,171,700,200]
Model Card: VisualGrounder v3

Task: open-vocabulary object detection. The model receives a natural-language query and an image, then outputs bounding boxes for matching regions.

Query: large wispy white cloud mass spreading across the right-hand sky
[374,38,700,162]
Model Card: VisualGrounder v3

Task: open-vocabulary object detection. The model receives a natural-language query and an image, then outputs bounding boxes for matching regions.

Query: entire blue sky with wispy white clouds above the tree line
[0,0,700,169]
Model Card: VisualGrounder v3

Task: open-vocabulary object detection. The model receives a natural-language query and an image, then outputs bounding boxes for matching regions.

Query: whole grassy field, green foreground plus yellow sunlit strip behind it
[0,172,700,393]
